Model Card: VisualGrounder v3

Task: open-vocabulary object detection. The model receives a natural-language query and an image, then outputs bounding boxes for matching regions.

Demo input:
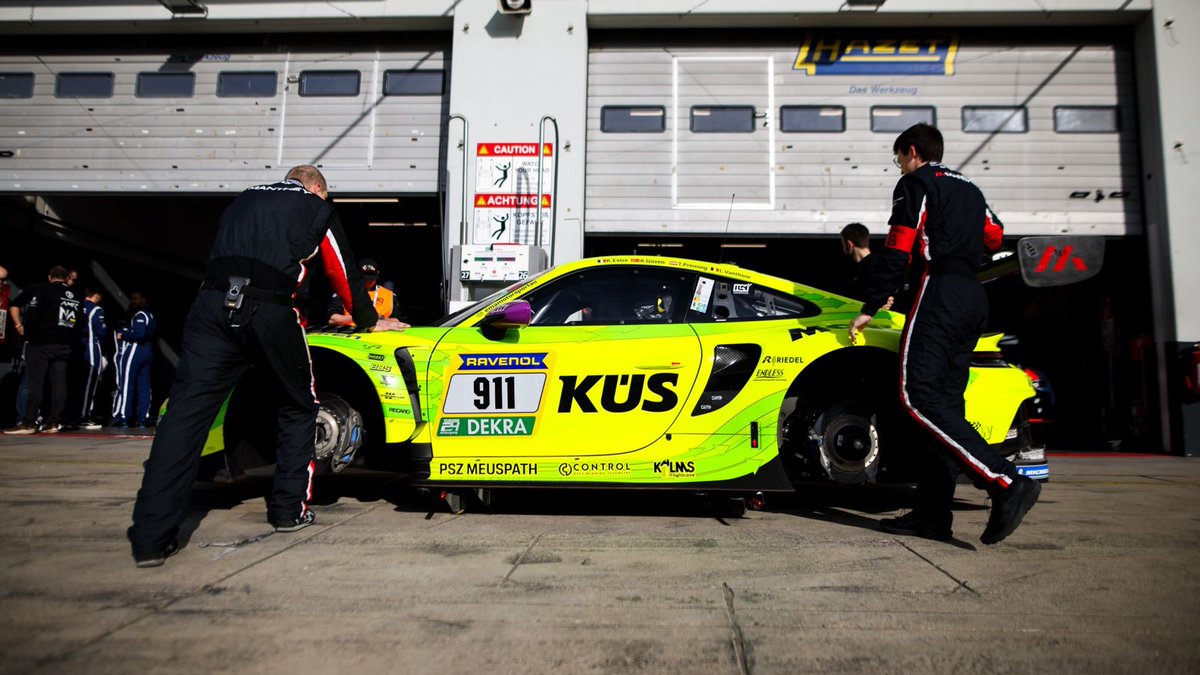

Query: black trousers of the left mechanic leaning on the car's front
[128,291,317,554]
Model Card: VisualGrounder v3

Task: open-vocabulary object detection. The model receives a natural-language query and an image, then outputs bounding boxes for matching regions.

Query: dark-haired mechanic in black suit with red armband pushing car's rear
[850,124,1042,544]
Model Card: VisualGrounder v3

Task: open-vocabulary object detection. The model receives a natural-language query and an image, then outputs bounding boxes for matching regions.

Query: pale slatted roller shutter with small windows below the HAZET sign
[586,37,1142,235]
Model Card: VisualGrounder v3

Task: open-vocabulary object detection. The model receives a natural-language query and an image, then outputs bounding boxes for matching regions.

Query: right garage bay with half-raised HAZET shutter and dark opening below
[584,28,1157,449]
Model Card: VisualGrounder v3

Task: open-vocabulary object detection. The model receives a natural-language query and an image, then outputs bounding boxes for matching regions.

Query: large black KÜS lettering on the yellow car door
[558,372,679,413]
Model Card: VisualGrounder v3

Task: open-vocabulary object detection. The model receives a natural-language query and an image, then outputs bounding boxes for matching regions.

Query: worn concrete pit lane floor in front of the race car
[0,435,1200,675]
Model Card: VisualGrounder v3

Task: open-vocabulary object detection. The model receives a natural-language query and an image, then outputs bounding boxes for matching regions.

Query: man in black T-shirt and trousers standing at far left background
[5,265,83,434]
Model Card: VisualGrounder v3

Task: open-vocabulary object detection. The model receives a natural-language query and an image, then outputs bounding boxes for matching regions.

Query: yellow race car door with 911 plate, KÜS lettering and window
[432,264,701,459]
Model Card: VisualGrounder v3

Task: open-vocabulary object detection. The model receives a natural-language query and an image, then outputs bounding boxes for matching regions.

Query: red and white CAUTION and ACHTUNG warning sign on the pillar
[473,143,554,244]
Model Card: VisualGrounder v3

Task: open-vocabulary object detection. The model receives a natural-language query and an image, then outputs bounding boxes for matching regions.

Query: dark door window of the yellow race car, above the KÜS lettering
[524,265,695,325]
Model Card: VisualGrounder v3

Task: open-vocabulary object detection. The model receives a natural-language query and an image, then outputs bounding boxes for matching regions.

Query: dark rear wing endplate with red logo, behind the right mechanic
[979,237,1104,288]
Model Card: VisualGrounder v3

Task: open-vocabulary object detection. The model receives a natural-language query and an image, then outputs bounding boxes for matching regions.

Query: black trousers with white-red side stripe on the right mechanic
[900,273,1016,525]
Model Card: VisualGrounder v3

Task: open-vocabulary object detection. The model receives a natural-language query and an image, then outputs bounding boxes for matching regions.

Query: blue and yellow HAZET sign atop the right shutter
[792,35,959,76]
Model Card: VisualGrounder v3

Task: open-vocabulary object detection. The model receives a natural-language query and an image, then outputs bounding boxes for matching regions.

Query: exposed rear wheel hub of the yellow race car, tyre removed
[809,404,880,485]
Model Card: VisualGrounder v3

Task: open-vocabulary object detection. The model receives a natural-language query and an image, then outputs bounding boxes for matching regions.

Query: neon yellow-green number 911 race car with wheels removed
[205,256,1046,492]
